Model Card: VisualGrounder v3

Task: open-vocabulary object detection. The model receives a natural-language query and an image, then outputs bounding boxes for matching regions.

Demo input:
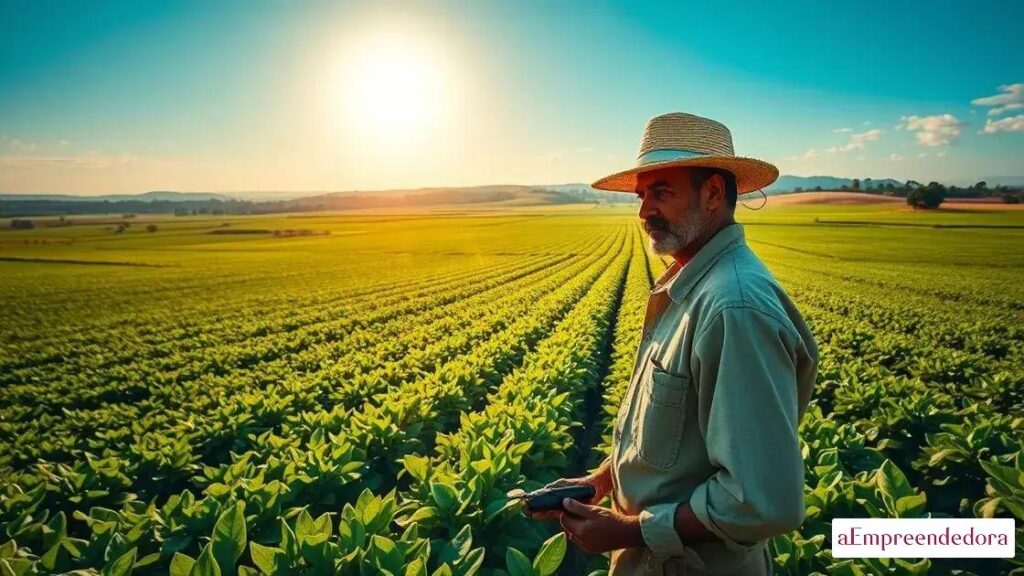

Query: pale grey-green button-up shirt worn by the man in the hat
[610,223,818,576]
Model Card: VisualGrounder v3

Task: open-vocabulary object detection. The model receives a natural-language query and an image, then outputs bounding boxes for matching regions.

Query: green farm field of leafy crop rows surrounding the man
[0,199,1024,576]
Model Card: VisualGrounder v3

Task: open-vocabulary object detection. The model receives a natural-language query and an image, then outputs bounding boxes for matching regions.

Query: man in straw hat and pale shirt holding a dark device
[535,113,818,576]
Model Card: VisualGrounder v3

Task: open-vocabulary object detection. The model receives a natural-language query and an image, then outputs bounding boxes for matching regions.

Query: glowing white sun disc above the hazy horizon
[340,34,447,146]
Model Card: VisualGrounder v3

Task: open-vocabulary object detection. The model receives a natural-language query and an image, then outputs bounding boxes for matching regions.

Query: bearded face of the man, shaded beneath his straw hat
[636,168,707,254]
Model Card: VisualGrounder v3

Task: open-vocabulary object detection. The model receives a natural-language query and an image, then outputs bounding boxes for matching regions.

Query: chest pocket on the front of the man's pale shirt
[633,362,690,469]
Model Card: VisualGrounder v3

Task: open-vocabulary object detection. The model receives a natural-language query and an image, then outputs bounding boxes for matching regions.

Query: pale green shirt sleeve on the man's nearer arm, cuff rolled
[689,306,806,551]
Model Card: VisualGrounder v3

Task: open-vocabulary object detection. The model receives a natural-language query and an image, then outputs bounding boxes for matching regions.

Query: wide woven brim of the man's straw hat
[590,156,778,196]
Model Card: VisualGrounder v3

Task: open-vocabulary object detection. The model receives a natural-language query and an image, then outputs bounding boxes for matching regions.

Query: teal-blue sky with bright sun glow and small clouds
[0,0,1024,195]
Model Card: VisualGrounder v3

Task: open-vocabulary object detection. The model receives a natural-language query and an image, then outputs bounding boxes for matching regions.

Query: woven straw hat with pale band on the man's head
[591,112,778,194]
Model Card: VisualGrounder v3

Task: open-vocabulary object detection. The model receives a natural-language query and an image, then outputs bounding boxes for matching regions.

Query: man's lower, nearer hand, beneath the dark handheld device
[561,498,644,553]
